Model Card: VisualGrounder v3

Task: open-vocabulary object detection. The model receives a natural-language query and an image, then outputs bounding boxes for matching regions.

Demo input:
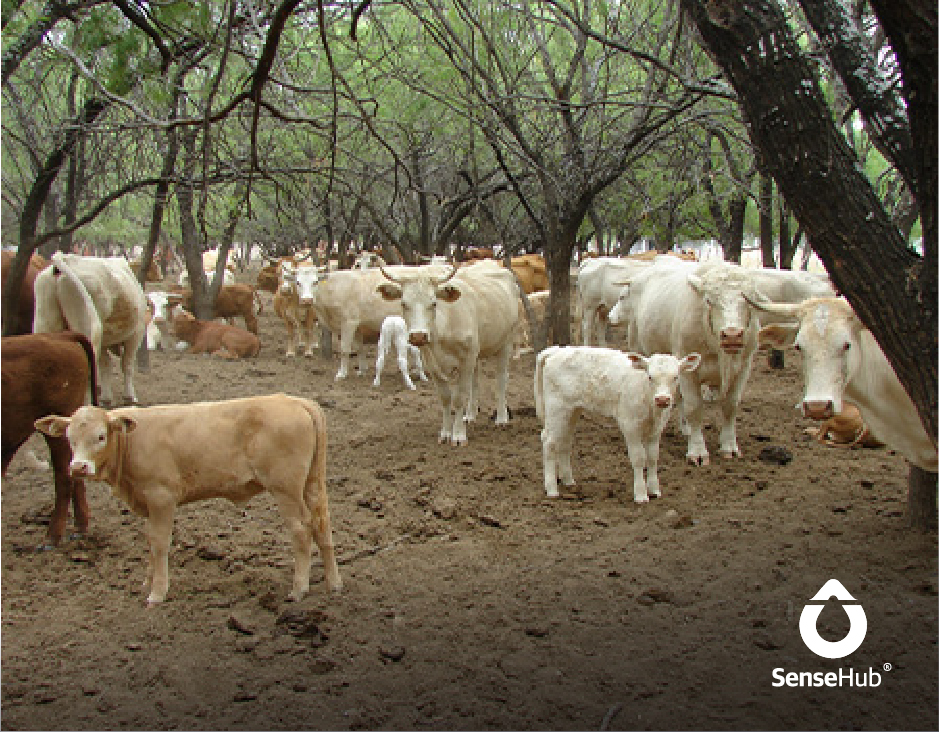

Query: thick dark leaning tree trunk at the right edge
[682,0,939,524]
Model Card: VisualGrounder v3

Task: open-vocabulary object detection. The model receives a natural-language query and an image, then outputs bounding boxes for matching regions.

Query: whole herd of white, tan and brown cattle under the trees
[2,244,937,605]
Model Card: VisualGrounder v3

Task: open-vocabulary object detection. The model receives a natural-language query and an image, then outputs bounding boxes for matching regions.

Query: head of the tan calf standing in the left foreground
[35,407,137,479]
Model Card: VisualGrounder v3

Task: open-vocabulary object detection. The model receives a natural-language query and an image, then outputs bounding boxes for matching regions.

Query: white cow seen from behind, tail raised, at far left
[33,252,147,404]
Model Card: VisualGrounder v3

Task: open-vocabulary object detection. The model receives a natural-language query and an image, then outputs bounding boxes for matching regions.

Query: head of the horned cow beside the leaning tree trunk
[752,297,864,420]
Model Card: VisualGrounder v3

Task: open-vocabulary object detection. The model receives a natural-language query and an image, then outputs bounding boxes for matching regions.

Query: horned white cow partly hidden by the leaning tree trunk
[751,297,939,473]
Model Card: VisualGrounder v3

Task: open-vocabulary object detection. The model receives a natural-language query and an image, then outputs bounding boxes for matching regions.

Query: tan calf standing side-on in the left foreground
[36,394,342,607]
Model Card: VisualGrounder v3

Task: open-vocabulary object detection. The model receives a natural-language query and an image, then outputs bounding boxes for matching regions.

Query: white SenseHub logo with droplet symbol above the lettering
[773,579,892,688]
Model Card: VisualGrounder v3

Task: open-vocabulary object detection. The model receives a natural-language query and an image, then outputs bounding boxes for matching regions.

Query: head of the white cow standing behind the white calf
[688,267,765,356]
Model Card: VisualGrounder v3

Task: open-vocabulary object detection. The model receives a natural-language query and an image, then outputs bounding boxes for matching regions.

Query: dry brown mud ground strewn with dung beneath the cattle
[2,278,939,730]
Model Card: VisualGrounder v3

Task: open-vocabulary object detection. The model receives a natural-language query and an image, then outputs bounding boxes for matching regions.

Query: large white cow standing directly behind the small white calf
[611,257,766,465]
